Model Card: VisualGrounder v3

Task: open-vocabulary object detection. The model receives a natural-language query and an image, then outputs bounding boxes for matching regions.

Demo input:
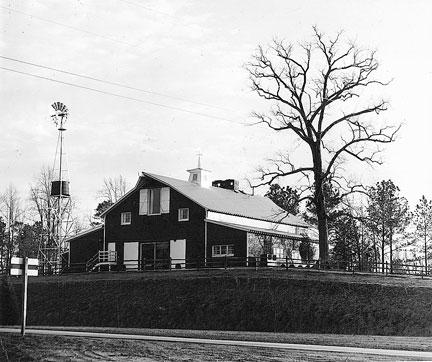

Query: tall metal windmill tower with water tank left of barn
[39,102,71,273]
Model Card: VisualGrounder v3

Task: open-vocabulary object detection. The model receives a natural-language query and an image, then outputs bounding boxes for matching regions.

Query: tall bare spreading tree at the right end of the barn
[247,27,400,262]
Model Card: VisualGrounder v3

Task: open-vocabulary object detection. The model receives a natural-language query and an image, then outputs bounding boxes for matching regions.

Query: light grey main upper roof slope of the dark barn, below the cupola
[142,172,308,227]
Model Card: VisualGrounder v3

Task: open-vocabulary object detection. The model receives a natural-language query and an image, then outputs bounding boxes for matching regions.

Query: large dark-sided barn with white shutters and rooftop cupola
[67,164,314,270]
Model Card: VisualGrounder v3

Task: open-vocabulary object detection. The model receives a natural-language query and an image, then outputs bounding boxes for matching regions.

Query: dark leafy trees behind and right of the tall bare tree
[266,180,432,272]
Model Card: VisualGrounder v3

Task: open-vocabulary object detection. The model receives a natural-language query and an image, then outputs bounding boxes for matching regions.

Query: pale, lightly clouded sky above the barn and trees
[0,0,432,222]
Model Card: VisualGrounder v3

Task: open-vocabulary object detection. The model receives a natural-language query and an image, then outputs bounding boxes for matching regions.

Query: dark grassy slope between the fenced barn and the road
[0,270,432,336]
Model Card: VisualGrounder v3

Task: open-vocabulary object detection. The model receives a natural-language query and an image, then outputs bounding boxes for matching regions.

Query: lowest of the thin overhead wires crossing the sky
[0,66,245,124]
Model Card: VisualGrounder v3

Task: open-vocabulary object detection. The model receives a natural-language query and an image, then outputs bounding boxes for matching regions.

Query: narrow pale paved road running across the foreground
[0,328,432,360]
